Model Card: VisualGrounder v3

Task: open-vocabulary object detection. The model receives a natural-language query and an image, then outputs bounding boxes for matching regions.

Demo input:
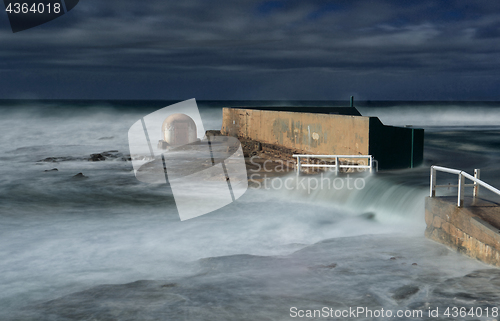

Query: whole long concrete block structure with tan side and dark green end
[221,99,424,169]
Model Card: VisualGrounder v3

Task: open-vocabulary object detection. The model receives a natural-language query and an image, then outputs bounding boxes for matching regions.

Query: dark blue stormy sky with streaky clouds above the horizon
[0,0,500,100]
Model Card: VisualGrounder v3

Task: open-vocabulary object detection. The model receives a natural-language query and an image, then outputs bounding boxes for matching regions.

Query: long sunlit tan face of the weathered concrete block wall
[221,108,369,155]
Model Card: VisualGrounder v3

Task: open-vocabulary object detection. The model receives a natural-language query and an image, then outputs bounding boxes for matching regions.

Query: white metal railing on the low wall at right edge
[430,165,500,207]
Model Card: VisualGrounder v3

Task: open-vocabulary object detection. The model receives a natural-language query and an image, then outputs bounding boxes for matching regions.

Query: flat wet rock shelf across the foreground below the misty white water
[9,235,500,321]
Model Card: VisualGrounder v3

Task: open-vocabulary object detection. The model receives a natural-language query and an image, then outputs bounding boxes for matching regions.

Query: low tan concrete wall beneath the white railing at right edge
[425,197,500,267]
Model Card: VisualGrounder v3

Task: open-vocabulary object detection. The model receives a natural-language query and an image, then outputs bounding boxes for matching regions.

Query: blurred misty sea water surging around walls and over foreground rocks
[0,101,500,320]
